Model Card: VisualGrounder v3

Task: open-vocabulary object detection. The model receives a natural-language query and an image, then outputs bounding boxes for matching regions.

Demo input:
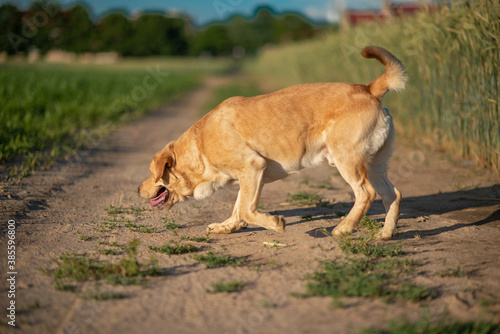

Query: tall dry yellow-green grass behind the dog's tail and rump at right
[256,0,500,171]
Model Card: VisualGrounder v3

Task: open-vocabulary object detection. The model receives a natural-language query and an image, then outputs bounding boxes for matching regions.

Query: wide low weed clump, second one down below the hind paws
[296,258,434,302]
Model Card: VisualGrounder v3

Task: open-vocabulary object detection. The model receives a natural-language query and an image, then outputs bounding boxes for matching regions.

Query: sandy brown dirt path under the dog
[0,79,500,333]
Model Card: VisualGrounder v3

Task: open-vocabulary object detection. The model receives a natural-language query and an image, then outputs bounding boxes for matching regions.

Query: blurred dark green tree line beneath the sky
[0,0,320,56]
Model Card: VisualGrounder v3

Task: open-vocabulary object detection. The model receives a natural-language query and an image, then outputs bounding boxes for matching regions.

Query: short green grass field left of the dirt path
[0,58,231,180]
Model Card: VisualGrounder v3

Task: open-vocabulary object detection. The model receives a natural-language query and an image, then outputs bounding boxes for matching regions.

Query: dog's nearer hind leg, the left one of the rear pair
[333,154,376,236]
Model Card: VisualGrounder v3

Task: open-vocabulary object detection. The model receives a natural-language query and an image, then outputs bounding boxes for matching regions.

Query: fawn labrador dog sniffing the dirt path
[138,46,407,240]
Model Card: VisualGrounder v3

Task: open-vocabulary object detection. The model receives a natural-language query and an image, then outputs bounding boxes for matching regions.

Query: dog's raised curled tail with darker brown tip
[361,46,408,99]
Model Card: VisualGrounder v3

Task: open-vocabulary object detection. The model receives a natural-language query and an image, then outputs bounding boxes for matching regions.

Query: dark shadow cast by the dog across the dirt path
[264,184,500,240]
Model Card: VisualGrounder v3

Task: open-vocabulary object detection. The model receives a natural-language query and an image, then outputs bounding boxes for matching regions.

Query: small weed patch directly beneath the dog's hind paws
[337,235,404,257]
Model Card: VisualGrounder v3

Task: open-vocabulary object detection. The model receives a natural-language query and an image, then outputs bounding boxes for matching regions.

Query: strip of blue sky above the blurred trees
[0,0,401,25]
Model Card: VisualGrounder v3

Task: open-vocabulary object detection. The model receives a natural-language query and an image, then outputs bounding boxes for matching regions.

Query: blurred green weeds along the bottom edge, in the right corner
[361,319,500,334]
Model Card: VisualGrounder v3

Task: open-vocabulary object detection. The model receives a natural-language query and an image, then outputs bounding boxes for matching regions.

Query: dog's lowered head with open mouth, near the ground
[137,142,191,210]
